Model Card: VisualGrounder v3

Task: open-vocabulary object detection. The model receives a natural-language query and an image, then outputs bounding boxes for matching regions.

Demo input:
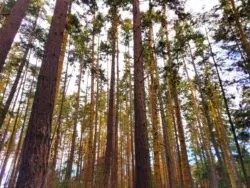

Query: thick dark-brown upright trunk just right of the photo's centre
[133,0,152,188]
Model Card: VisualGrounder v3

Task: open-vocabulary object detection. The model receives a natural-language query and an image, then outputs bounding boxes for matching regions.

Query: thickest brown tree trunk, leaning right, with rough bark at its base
[17,0,70,188]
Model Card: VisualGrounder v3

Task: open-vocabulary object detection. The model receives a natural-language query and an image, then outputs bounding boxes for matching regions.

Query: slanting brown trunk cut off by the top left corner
[0,0,30,73]
